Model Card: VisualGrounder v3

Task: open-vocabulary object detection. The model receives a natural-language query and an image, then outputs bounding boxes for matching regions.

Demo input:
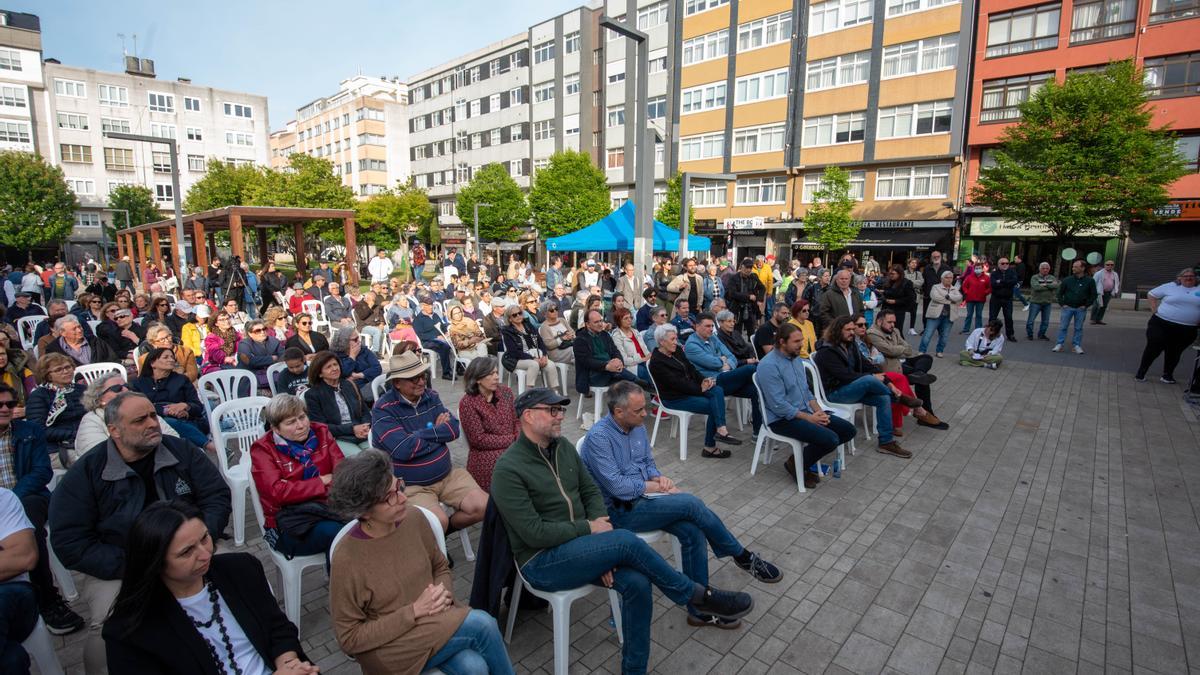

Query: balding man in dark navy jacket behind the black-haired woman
[50,392,232,675]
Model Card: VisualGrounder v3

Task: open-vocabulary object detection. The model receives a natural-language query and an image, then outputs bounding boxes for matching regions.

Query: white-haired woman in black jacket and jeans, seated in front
[647,323,742,459]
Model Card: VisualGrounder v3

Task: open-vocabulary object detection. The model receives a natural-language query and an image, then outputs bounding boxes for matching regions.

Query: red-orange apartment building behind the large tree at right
[960,0,1200,283]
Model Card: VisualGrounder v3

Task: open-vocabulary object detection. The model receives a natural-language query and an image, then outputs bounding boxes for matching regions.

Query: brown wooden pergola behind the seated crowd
[116,207,359,283]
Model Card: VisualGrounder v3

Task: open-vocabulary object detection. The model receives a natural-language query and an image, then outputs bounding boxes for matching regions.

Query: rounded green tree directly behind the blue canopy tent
[529,150,612,239]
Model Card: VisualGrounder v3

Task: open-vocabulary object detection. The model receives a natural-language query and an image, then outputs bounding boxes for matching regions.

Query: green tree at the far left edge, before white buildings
[0,150,79,256]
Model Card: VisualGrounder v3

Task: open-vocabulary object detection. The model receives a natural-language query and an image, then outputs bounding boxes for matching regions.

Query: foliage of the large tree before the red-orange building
[972,61,1184,240]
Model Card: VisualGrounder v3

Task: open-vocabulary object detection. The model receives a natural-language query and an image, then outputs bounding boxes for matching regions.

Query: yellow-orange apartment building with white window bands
[679,0,974,263]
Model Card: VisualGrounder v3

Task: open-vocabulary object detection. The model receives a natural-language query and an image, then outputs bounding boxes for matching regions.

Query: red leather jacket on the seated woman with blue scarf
[250,422,343,527]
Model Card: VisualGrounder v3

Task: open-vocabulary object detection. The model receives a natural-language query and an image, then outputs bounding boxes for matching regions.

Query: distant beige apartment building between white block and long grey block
[269,76,410,197]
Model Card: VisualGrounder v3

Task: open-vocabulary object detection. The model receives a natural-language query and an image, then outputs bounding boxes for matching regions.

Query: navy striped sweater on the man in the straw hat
[371,388,460,485]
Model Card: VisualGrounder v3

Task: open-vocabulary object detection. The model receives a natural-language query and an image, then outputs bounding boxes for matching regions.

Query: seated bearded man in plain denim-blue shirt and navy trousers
[757,323,857,490]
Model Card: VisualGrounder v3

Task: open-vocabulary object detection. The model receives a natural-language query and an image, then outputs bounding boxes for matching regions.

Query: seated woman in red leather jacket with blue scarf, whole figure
[250,394,346,556]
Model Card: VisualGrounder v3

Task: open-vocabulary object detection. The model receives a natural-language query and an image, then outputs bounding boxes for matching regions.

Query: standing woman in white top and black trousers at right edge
[1134,268,1200,384]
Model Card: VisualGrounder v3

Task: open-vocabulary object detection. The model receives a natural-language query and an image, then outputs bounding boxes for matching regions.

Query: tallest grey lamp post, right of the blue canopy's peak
[600,16,658,275]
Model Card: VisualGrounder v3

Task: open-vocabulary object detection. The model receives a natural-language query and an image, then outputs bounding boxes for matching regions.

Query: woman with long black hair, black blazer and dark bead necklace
[103,501,318,675]
